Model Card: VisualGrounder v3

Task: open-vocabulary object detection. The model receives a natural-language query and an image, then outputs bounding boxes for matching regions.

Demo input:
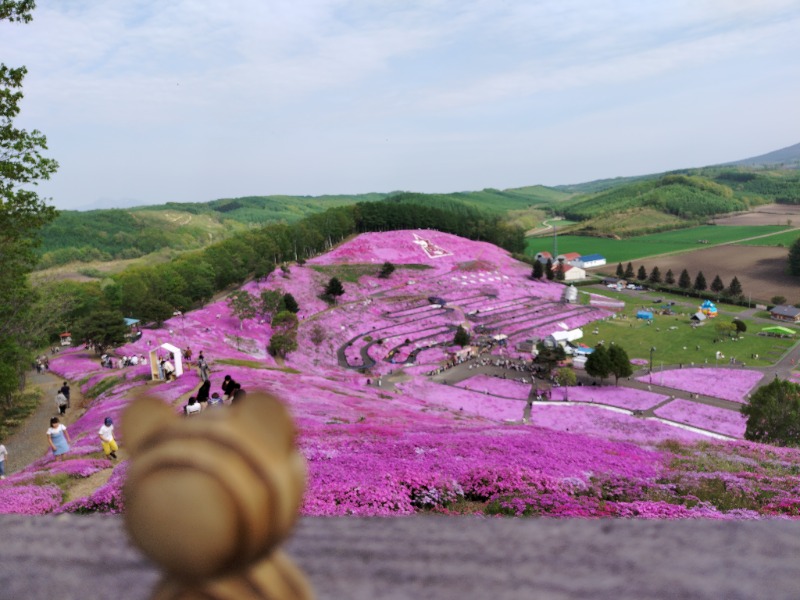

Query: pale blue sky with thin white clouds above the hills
[0,0,800,208]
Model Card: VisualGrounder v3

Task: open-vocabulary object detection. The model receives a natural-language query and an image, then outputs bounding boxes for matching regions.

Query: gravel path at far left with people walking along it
[4,372,83,475]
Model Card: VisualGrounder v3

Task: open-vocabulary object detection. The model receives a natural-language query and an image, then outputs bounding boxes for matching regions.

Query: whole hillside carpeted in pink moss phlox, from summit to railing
[0,230,800,518]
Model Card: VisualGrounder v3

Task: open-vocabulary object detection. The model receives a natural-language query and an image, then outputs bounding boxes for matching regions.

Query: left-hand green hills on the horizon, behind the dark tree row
[39,186,569,268]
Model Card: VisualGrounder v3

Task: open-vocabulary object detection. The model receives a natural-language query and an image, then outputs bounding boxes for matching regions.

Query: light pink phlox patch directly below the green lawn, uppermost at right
[638,368,764,403]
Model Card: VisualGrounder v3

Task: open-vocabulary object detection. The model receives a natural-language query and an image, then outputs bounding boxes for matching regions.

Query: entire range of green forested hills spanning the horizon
[40,165,800,268]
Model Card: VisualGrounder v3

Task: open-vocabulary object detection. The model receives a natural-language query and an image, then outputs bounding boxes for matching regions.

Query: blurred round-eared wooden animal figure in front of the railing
[122,394,313,600]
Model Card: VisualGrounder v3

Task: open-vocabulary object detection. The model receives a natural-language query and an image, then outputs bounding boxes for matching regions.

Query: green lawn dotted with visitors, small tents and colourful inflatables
[581,290,797,367]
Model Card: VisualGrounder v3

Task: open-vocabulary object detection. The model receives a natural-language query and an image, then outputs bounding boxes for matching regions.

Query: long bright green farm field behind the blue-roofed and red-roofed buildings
[525,225,787,263]
